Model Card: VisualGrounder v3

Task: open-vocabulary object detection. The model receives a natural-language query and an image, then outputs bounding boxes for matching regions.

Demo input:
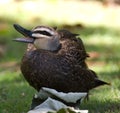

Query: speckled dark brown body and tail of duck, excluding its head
[13,24,107,92]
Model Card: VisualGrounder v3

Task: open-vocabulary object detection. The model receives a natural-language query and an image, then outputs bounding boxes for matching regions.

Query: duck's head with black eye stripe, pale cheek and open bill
[13,24,60,51]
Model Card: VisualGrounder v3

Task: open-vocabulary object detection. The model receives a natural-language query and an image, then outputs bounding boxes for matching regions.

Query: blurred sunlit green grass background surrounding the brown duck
[0,0,120,113]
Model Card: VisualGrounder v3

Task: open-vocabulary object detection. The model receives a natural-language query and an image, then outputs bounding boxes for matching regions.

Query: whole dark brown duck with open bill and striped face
[13,24,110,93]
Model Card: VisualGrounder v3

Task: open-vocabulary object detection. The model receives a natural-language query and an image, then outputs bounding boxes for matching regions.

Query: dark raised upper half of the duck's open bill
[13,24,32,38]
